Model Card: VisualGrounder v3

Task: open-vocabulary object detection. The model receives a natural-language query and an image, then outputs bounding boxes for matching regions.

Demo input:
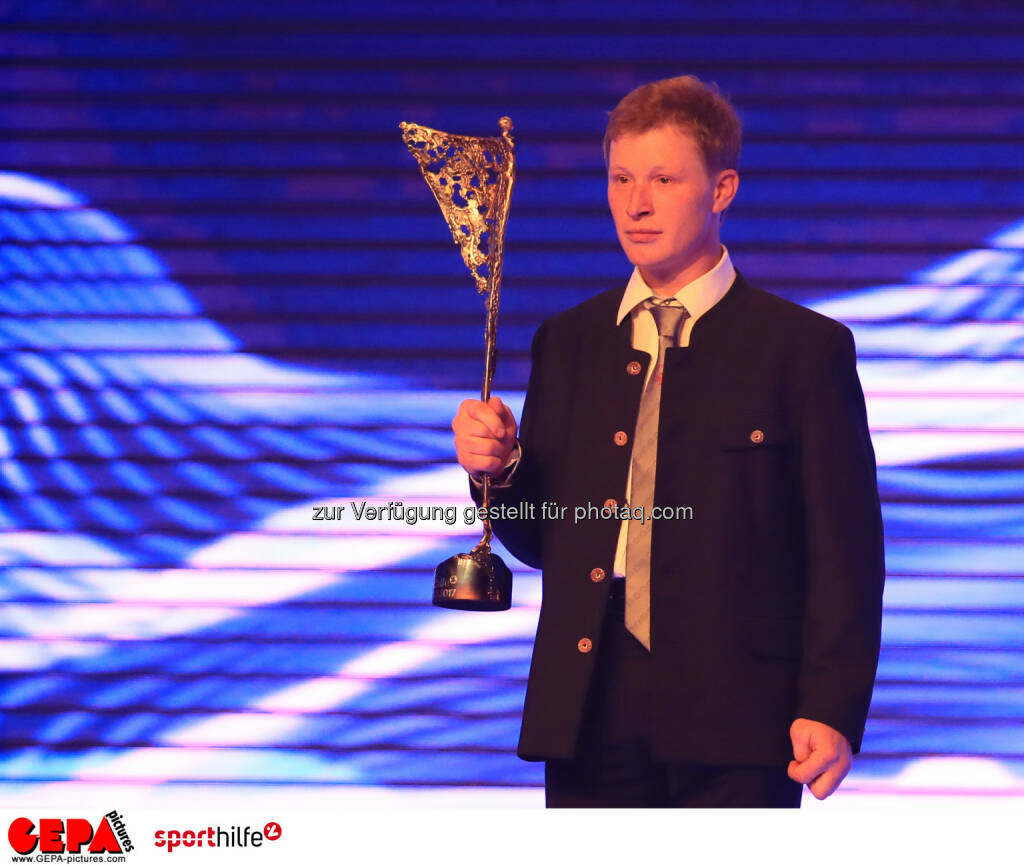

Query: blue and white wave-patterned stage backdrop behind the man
[0,0,1024,793]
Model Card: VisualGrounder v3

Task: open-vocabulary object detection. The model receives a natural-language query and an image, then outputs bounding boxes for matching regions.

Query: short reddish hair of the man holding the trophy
[604,75,741,174]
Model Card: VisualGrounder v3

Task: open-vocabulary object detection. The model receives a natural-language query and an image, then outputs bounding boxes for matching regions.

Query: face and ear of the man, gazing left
[608,125,736,289]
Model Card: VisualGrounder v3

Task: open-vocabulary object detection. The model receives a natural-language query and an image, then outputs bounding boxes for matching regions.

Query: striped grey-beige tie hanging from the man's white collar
[626,298,689,650]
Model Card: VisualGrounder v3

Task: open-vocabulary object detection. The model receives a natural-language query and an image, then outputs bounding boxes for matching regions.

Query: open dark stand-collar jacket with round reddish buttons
[474,274,885,765]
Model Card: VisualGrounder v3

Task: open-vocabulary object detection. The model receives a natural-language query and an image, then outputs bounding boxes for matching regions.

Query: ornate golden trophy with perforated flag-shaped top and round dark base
[399,118,515,610]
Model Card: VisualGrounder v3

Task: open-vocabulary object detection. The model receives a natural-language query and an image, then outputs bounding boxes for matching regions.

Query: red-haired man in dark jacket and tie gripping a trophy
[452,76,884,807]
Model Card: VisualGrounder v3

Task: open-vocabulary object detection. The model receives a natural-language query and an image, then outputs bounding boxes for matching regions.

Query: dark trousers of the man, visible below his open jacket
[544,580,804,809]
